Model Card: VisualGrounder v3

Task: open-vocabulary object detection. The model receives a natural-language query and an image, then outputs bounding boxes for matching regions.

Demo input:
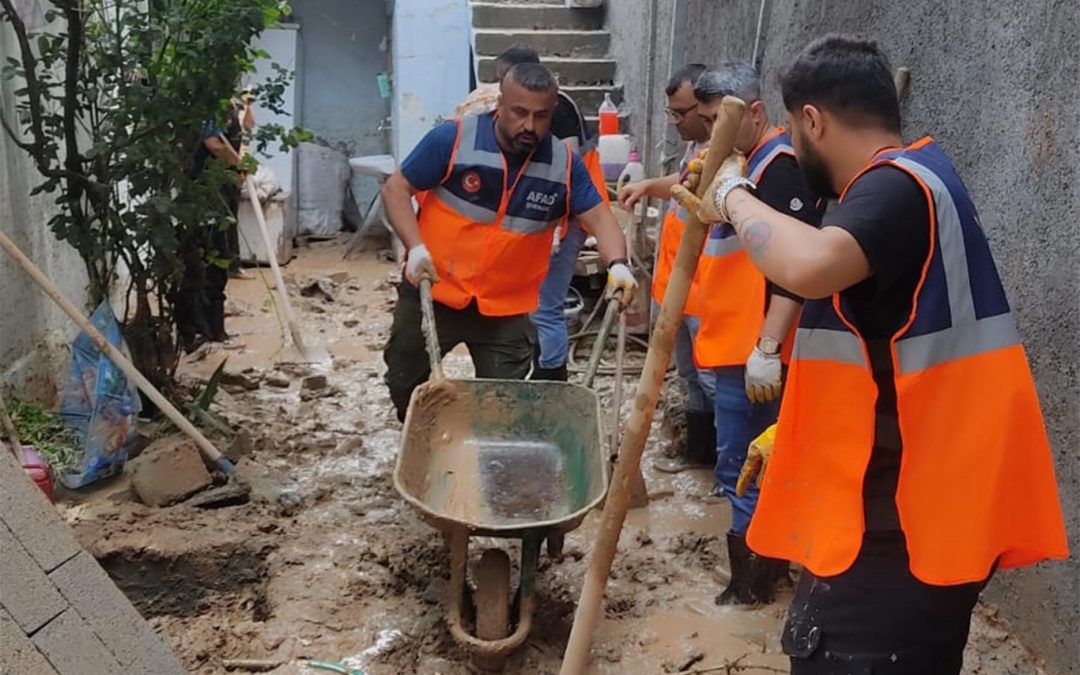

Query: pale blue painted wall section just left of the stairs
[392,0,472,160]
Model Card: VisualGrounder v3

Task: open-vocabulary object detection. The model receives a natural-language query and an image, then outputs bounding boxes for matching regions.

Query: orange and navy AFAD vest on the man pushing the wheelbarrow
[419,113,572,316]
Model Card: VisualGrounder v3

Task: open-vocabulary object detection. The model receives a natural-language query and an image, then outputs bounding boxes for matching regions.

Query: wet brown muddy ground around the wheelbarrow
[56,242,1041,675]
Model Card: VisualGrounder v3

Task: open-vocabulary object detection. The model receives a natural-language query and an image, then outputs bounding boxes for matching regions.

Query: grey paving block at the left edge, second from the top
[0,525,67,633]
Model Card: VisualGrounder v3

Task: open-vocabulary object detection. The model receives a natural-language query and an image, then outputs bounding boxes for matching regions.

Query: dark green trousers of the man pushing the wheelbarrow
[382,281,536,421]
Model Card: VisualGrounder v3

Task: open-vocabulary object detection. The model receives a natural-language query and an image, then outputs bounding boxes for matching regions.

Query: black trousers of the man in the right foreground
[782,531,988,675]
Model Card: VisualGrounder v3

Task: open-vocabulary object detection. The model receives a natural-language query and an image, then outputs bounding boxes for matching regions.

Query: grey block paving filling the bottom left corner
[0,444,187,675]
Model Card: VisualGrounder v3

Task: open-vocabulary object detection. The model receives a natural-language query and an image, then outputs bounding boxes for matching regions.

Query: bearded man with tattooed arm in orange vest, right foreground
[678,36,1068,675]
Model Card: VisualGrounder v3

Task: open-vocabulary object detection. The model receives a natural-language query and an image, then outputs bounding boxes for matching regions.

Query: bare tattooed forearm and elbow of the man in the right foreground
[726,189,870,298]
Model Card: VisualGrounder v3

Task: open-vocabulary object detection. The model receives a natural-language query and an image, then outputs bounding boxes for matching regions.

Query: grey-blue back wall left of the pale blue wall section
[291,0,390,205]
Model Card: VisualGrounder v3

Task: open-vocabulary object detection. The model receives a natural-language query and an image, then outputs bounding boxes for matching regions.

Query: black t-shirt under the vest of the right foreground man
[822,164,930,531]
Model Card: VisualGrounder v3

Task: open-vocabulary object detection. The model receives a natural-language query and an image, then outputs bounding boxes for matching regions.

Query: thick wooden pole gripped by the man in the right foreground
[559,96,746,675]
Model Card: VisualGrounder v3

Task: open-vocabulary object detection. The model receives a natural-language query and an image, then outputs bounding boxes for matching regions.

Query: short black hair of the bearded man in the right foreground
[780,35,900,134]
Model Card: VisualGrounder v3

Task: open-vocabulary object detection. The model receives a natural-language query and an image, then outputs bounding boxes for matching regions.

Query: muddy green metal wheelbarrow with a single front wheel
[394,281,618,670]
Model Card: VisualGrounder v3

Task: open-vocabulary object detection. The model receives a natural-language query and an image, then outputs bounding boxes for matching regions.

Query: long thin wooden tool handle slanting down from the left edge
[0,232,237,475]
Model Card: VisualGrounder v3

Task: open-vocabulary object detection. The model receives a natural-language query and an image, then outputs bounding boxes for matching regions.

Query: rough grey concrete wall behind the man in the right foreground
[687,0,1080,673]
